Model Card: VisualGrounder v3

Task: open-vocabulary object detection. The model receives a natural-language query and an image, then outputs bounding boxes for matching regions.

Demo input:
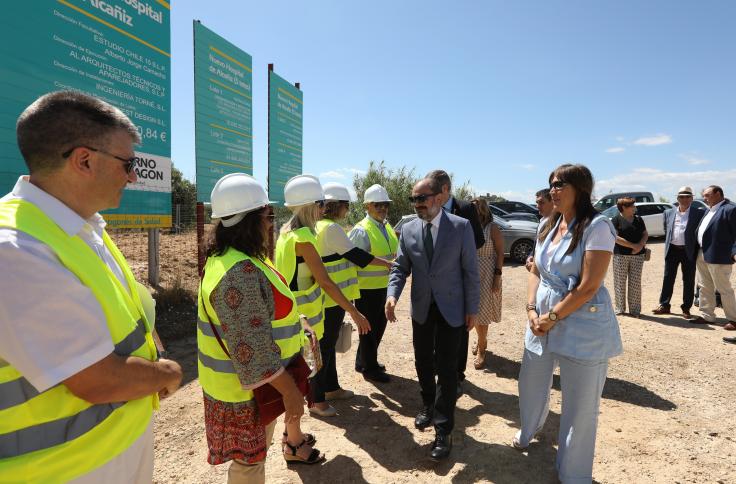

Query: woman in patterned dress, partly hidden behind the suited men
[473,198,503,370]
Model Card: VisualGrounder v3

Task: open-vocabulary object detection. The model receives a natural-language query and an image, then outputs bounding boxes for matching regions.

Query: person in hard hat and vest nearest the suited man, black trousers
[349,183,399,383]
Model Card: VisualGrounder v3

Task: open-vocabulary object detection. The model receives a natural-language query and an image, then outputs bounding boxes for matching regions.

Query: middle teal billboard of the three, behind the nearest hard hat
[194,20,253,203]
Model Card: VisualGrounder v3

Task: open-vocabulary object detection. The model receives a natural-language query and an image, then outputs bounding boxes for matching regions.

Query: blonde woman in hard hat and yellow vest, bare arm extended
[275,175,370,417]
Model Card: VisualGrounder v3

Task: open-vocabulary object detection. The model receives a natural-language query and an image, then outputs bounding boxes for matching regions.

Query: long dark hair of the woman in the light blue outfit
[539,164,598,254]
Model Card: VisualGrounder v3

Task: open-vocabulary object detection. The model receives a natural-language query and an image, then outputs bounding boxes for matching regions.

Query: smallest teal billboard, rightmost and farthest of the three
[268,71,304,204]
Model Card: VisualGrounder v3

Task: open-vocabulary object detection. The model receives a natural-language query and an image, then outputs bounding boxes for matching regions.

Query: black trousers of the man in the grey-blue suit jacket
[411,303,466,434]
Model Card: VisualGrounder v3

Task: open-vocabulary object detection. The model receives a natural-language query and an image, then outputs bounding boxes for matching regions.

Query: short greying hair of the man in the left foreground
[16,91,140,173]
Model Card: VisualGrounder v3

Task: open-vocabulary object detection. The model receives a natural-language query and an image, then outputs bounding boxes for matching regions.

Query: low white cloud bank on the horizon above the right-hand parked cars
[595,168,736,201]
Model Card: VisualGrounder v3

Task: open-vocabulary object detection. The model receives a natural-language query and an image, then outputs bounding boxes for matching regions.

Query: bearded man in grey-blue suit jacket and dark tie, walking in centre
[386,178,480,460]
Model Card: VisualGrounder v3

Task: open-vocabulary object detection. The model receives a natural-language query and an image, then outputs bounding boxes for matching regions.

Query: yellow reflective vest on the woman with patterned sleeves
[197,248,304,403]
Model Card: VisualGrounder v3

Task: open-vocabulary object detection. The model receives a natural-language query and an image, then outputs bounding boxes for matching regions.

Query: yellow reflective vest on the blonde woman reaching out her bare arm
[274,227,325,339]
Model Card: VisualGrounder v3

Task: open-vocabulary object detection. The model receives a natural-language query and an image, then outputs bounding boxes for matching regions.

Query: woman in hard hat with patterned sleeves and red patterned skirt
[197,173,324,482]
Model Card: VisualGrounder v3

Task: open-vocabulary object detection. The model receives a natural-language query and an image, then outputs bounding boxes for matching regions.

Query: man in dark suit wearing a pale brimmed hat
[652,187,705,319]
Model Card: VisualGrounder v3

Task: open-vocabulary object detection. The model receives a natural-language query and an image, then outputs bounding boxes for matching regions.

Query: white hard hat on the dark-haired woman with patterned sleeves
[210,173,273,227]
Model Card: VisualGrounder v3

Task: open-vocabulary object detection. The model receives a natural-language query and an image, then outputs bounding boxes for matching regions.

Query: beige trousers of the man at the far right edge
[696,250,736,323]
